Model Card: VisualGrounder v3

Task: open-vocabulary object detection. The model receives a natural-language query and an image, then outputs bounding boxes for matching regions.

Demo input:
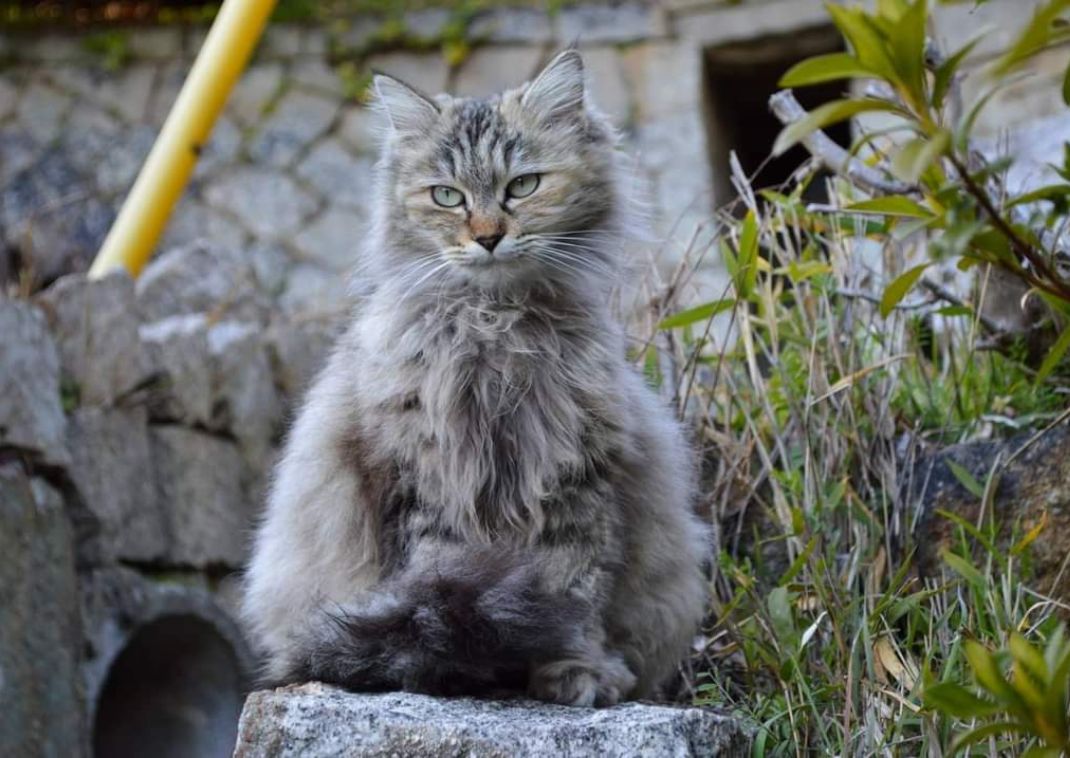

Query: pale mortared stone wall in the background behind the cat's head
[0,0,1065,301]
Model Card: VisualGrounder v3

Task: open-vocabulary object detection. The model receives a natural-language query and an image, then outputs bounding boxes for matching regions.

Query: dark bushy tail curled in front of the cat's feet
[285,549,590,695]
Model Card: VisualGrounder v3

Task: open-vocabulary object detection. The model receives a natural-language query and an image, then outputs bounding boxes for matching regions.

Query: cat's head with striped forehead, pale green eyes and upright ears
[376,50,615,286]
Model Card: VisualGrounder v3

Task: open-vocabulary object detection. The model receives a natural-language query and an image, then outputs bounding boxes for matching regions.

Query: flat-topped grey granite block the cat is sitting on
[234,683,750,758]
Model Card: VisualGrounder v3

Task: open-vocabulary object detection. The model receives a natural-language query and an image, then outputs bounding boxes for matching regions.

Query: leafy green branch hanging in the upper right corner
[774,0,1070,378]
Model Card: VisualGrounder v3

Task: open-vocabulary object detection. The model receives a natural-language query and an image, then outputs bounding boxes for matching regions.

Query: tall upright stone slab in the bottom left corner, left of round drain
[0,464,87,756]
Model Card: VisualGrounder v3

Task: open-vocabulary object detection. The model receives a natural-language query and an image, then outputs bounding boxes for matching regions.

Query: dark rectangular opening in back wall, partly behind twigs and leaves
[706,27,851,206]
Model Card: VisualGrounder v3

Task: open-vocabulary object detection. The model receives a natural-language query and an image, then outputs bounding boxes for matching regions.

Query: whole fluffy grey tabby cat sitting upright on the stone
[244,50,707,704]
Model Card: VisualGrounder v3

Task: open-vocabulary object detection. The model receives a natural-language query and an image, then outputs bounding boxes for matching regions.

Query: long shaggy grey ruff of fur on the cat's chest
[361,293,621,531]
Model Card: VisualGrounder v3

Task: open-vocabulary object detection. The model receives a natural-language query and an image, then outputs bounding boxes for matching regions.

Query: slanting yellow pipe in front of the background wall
[89,0,276,278]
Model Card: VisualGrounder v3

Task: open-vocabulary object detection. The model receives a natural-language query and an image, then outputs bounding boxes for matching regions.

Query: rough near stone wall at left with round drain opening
[0,244,334,756]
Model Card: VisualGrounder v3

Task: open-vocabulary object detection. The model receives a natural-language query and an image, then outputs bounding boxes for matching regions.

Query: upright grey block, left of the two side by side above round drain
[67,408,167,563]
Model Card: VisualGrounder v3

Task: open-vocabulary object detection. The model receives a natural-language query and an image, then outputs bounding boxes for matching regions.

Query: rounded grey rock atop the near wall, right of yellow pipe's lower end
[136,240,269,322]
